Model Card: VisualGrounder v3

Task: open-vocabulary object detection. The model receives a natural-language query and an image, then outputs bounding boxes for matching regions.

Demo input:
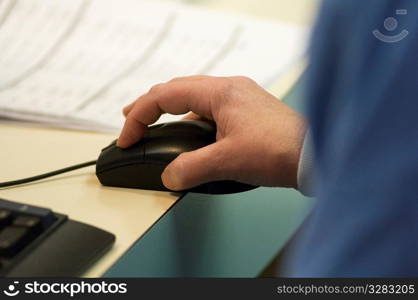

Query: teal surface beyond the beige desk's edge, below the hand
[104,77,313,277]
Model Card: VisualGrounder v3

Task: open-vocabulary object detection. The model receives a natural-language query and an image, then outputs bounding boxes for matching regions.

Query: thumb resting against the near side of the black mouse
[161,140,227,191]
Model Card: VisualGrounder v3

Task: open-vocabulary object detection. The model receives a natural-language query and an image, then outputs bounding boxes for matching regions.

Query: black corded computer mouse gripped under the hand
[96,120,256,194]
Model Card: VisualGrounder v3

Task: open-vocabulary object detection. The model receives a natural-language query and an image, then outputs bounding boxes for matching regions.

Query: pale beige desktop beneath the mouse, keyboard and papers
[0,0,316,277]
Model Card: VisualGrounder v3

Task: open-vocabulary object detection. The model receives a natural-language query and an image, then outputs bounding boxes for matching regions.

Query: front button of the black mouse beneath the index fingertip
[96,143,145,172]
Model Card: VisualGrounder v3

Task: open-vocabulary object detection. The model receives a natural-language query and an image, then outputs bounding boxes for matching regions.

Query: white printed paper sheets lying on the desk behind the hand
[0,0,307,131]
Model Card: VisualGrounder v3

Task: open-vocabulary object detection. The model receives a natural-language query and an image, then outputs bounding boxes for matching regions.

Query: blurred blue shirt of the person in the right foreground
[286,0,418,277]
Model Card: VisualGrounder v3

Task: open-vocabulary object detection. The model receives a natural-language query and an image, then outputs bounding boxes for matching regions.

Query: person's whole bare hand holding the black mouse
[117,76,306,190]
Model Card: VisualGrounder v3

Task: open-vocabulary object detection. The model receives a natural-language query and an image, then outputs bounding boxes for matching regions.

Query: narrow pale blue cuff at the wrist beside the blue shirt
[297,130,316,197]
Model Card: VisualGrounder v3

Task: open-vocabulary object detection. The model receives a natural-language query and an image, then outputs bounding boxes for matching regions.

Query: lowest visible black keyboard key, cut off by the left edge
[0,226,31,256]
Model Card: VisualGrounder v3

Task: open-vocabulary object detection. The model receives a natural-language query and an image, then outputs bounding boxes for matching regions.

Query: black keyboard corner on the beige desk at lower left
[0,199,115,277]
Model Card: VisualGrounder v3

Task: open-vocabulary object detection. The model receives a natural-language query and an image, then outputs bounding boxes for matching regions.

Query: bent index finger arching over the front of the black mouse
[117,77,219,148]
